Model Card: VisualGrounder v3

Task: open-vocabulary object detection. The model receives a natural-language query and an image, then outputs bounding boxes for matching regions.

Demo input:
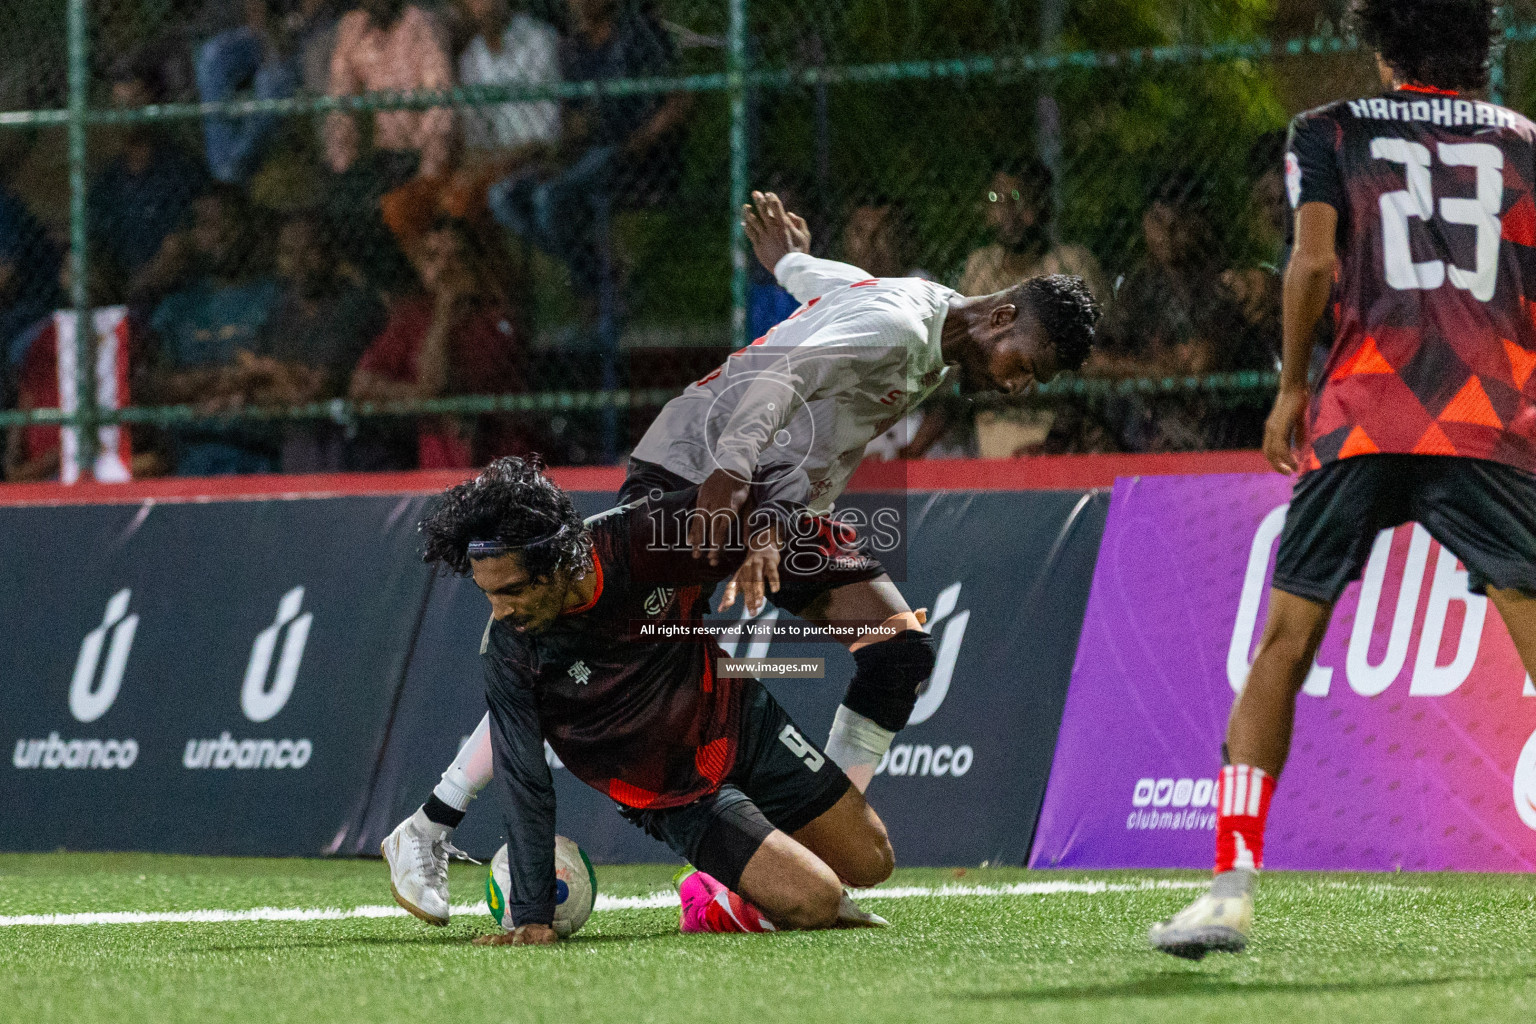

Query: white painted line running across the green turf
[0,878,1422,927]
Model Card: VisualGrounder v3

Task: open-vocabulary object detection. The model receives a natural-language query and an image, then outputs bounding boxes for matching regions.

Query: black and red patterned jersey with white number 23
[1286,88,1536,471]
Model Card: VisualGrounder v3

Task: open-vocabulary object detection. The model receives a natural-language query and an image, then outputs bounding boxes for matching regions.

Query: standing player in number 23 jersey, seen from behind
[1147,0,1536,960]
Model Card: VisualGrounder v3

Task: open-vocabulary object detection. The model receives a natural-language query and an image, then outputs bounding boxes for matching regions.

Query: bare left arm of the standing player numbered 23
[1264,203,1339,474]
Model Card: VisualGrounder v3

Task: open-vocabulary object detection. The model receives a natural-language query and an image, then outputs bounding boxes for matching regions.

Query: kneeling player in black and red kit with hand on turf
[421,457,895,944]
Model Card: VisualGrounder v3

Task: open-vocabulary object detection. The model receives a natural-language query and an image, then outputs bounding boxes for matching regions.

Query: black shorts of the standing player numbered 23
[1275,454,1536,603]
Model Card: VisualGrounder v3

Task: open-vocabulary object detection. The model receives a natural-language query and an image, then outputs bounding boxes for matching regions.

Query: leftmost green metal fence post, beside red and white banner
[69,0,97,479]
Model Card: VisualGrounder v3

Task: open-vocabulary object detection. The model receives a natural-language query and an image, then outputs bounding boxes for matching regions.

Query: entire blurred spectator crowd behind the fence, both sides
[0,0,1284,481]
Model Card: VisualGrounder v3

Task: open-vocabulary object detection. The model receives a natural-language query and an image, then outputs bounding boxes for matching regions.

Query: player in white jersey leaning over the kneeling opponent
[384,192,1098,924]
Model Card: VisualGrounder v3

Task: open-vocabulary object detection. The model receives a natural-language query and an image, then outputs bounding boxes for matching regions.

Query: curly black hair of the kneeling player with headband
[416,454,591,579]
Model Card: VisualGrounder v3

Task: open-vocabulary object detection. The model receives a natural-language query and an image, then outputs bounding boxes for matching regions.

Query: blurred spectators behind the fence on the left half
[0,0,690,481]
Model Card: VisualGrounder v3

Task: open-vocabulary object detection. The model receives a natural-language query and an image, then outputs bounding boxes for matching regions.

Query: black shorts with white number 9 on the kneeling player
[619,680,852,890]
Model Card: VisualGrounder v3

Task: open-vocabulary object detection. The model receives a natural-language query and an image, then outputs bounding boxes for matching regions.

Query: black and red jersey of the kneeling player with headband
[481,487,879,924]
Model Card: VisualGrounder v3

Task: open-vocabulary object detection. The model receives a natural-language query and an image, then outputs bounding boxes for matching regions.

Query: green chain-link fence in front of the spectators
[0,0,1536,479]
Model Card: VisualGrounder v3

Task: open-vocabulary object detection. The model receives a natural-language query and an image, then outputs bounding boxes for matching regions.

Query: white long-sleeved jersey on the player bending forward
[633,253,957,511]
